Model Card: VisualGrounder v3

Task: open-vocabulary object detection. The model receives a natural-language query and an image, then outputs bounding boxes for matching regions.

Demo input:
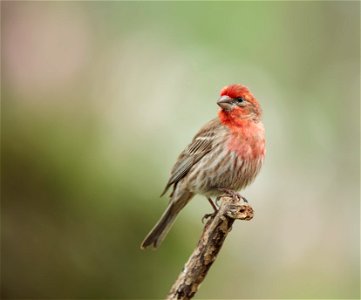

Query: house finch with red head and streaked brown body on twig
[141,84,265,249]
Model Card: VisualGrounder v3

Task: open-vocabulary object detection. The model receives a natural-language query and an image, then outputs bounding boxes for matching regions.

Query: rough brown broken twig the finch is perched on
[167,196,253,300]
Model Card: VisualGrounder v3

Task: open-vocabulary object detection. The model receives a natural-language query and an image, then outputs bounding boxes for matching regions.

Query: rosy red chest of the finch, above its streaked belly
[227,123,266,161]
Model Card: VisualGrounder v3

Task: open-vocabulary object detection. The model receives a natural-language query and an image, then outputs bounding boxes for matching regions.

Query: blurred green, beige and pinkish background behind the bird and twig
[1,1,360,299]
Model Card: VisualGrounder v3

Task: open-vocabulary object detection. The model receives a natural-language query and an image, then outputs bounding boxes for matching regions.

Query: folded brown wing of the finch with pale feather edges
[161,119,220,196]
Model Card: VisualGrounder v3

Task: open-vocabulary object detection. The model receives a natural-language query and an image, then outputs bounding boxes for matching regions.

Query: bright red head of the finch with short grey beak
[217,84,262,122]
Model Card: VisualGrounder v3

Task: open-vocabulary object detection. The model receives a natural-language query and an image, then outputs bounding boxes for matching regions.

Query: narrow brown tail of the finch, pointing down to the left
[140,193,193,249]
